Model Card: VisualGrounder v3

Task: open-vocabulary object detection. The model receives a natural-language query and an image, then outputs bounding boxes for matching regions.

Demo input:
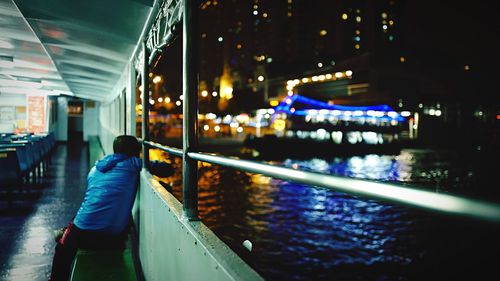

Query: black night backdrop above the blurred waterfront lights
[155,0,500,107]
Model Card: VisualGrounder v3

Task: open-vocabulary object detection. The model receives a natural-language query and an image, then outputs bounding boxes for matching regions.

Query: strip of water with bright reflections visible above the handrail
[282,149,492,201]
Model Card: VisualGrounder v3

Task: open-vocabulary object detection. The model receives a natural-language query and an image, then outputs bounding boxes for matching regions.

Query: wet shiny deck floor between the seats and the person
[0,144,89,281]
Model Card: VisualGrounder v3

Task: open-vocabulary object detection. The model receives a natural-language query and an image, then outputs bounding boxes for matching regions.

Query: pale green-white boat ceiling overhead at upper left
[0,0,156,101]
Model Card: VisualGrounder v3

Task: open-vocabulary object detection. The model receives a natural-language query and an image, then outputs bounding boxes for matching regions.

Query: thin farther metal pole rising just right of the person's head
[141,40,149,168]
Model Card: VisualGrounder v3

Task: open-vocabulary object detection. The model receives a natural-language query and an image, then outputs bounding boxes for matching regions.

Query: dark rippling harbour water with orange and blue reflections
[159,150,500,280]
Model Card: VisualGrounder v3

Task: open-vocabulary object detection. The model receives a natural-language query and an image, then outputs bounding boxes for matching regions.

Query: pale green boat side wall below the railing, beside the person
[134,170,263,281]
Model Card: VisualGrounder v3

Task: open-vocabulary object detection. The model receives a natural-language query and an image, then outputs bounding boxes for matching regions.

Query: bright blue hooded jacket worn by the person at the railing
[74,154,142,234]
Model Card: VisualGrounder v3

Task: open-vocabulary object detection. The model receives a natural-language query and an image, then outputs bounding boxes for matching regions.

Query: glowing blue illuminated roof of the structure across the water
[274,95,405,122]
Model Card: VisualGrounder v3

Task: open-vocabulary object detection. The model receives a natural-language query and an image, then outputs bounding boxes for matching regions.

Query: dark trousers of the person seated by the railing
[50,222,128,281]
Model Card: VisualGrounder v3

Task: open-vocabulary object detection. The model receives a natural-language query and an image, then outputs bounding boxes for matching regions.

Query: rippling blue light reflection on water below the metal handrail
[254,181,419,280]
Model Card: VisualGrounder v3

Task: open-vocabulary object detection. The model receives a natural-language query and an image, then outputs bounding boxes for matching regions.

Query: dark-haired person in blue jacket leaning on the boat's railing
[49,135,174,281]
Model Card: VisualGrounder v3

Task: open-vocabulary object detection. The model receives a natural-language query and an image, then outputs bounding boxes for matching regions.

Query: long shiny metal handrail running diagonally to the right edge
[144,141,500,223]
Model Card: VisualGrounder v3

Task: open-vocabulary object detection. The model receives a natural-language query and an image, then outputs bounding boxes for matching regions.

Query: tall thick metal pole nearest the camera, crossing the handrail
[182,0,199,220]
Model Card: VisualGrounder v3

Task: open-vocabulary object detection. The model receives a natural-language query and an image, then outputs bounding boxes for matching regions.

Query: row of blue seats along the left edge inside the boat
[0,133,56,208]
